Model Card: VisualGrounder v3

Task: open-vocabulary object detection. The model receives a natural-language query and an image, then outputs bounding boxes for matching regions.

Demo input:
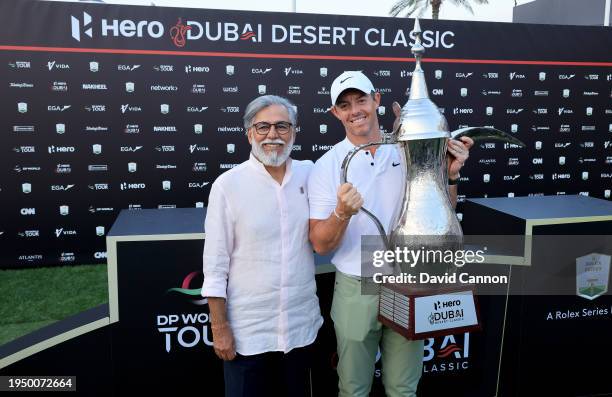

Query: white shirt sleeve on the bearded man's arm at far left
[202,180,234,298]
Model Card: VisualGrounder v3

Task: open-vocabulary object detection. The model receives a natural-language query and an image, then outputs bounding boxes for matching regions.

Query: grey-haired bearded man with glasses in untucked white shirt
[202,95,323,397]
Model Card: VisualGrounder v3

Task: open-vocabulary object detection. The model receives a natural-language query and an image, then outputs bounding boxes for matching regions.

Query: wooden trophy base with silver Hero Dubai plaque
[378,284,482,340]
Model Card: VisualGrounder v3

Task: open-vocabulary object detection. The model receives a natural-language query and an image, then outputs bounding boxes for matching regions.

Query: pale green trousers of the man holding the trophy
[331,271,423,397]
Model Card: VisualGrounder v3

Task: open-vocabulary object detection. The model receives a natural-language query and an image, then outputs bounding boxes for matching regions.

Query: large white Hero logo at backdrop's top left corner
[70,12,164,42]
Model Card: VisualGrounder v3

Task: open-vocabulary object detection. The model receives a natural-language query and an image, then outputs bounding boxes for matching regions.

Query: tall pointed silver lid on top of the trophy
[397,18,450,141]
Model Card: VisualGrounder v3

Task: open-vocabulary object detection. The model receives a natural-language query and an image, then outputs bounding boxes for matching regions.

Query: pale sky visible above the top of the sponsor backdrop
[52,0,533,22]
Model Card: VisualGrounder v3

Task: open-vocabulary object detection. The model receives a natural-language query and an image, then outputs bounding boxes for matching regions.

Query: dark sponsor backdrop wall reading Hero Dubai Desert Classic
[0,1,612,268]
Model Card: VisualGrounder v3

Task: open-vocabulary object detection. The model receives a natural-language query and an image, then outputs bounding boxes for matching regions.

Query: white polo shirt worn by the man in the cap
[308,138,405,276]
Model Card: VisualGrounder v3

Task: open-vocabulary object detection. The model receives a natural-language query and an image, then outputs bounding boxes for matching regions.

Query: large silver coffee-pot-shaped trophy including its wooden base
[341,19,524,339]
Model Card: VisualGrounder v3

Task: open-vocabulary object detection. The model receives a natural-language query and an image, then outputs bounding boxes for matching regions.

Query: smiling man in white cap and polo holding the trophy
[308,71,473,397]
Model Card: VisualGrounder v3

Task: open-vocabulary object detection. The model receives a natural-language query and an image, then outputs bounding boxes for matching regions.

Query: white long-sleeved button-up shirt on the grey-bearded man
[202,154,323,355]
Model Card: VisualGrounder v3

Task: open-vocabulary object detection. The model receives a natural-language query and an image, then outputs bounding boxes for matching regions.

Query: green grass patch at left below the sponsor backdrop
[0,264,108,345]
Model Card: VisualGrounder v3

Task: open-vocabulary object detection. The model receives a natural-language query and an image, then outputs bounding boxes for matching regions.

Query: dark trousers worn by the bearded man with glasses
[223,346,312,397]
